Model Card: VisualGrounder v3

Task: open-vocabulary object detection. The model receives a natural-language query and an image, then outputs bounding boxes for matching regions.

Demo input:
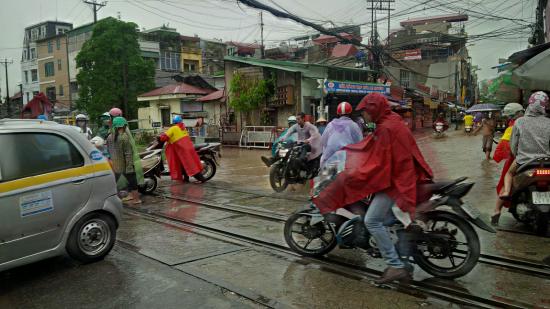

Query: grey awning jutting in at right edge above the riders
[512,49,550,90]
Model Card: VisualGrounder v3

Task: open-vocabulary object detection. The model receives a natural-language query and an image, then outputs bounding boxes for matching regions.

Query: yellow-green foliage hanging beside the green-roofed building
[229,73,276,112]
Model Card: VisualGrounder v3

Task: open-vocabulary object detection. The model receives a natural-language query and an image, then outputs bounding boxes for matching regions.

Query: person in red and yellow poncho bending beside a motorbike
[159,116,209,182]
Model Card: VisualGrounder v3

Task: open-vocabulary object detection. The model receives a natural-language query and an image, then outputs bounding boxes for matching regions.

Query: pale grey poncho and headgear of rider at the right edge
[510,91,550,165]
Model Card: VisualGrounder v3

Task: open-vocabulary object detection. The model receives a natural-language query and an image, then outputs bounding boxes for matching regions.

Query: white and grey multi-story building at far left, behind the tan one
[21,21,73,104]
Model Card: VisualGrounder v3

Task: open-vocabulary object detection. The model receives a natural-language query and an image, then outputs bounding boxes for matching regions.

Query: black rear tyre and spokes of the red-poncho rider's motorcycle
[413,211,480,279]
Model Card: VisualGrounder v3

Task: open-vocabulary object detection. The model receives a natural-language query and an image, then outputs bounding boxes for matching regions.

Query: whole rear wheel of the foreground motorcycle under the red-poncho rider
[413,211,480,279]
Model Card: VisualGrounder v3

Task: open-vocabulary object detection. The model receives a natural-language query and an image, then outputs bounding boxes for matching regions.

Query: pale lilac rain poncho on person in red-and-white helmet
[321,116,363,167]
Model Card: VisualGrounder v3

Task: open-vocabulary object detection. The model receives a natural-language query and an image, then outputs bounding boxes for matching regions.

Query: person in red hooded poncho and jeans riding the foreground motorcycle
[313,93,432,284]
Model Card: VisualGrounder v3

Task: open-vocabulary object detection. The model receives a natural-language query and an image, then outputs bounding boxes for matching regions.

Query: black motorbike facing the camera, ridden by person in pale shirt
[269,141,321,192]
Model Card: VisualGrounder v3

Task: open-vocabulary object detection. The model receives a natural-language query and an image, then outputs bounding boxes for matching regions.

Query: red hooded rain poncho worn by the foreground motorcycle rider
[313,93,432,217]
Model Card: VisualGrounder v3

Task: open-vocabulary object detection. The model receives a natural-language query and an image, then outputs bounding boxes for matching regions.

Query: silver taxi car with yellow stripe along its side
[0,119,122,271]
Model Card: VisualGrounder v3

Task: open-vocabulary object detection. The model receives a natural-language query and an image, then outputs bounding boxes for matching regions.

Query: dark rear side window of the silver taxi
[0,133,84,181]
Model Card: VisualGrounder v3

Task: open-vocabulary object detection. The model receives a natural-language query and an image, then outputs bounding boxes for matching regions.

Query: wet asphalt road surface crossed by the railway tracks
[4,131,550,308]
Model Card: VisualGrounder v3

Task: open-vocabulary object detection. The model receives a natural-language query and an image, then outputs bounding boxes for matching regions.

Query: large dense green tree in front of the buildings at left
[76,17,155,119]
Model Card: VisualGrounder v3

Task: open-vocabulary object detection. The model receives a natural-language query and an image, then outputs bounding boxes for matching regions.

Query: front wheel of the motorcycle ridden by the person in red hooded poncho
[284,213,336,257]
